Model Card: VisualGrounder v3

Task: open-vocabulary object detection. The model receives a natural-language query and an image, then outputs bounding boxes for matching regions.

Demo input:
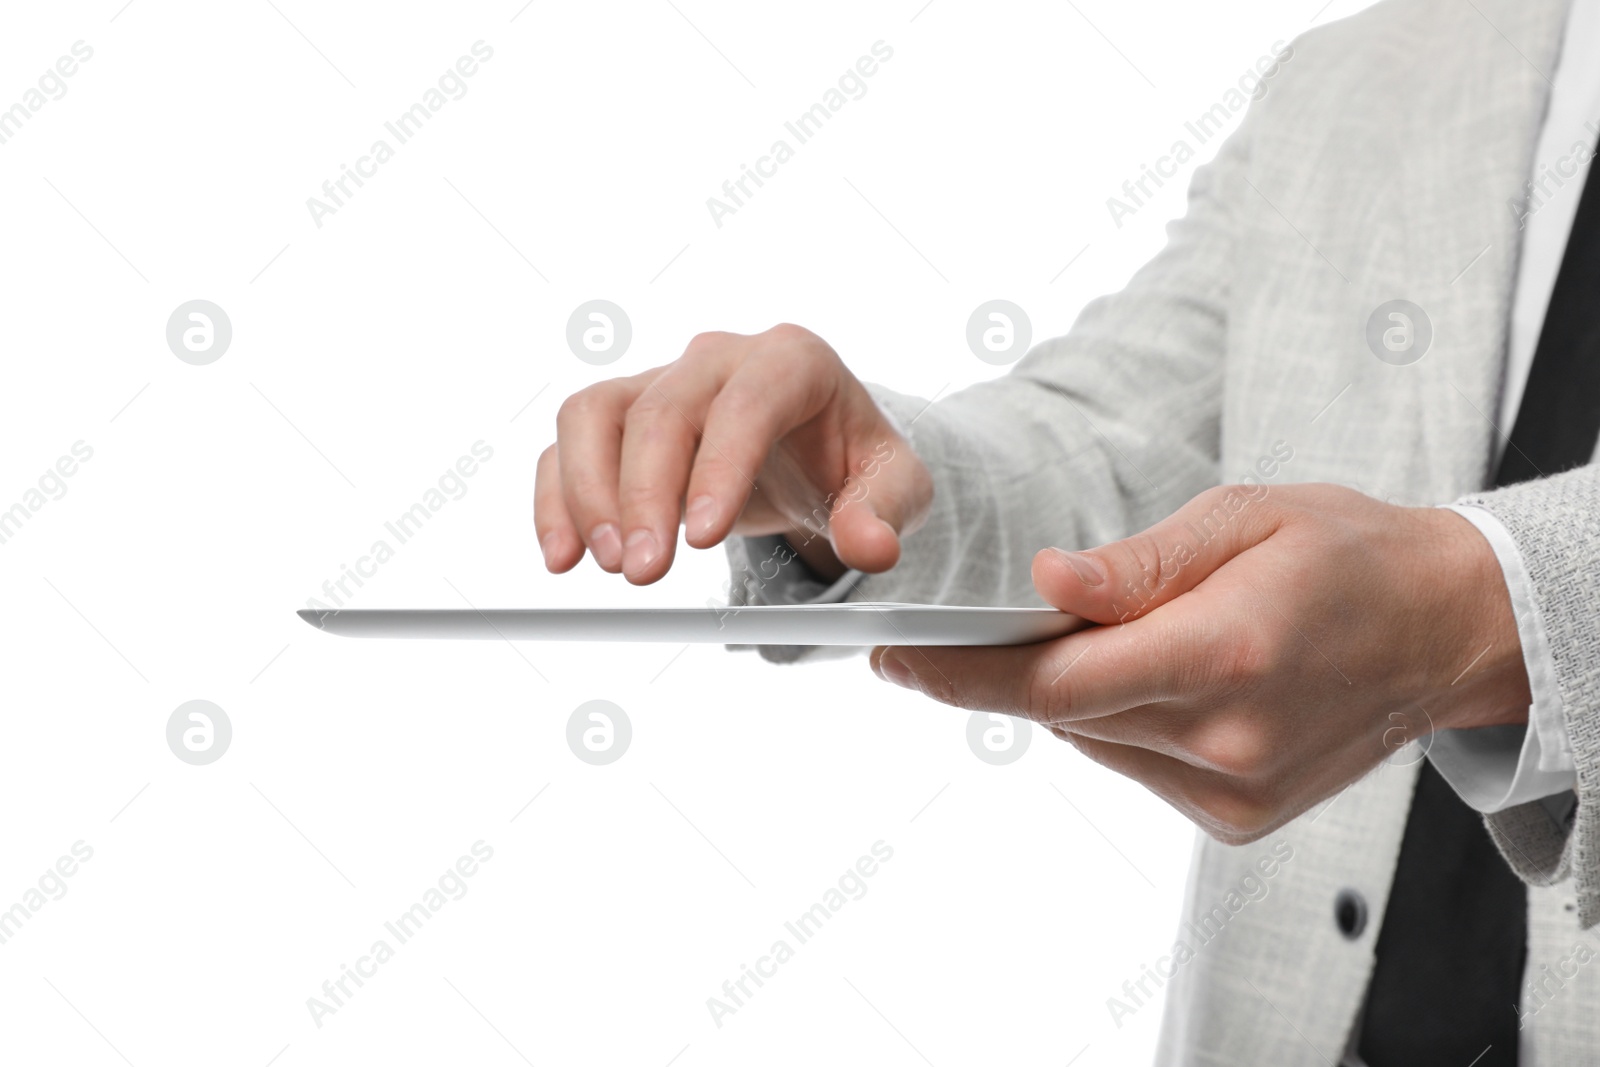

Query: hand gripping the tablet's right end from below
[872,485,1531,845]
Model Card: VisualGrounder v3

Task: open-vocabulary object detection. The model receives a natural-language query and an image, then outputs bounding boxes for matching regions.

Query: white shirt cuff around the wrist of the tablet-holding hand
[1427,504,1578,814]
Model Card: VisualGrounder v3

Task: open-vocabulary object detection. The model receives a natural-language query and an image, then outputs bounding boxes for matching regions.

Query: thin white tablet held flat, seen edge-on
[299,603,1088,645]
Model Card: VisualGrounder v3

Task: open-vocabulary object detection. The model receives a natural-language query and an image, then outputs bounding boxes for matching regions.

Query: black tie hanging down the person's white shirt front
[1360,150,1600,1049]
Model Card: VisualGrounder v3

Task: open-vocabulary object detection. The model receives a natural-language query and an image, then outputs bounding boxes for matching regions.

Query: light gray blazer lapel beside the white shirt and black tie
[1386,0,1566,499]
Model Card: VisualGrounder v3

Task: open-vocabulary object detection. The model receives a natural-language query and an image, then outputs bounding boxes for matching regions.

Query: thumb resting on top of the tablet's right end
[1034,485,1280,622]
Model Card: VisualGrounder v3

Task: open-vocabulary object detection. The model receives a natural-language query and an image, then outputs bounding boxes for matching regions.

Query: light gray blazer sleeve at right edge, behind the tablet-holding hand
[1462,464,1600,928]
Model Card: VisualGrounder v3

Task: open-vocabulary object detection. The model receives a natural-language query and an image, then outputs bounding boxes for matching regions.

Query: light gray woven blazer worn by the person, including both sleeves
[730,0,1600,1067]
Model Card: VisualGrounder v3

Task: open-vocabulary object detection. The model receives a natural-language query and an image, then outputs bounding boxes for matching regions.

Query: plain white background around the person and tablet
[0,0,1376,1067]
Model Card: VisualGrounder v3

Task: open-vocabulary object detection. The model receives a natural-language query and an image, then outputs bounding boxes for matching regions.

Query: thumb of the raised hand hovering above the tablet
[827,422,933,574]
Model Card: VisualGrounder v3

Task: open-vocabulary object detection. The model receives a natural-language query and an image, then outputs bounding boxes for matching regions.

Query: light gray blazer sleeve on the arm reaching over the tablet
[728,117,1253,662]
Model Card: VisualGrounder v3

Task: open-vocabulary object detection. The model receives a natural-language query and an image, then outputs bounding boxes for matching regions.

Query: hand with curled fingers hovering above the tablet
[533,325,933,585]
